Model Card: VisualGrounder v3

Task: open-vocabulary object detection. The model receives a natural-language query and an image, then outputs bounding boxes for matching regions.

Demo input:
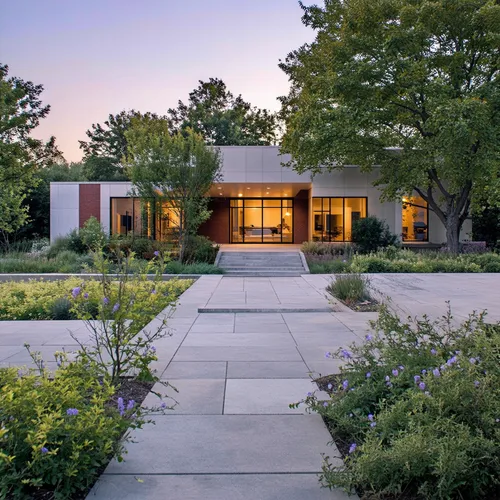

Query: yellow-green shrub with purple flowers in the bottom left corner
[0,355,145,500]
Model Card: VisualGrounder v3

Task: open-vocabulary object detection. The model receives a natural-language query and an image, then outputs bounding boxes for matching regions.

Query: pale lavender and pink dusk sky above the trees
[0,0,318,161]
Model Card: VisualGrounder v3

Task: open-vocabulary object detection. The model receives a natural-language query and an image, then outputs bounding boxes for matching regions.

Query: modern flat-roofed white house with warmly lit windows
[50,146,471,244]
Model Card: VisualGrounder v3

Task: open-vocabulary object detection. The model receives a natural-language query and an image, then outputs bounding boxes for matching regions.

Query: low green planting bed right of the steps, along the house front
[303,243,500,274]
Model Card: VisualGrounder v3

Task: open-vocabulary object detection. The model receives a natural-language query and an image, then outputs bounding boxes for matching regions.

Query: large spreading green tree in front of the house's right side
[280,0,500,252]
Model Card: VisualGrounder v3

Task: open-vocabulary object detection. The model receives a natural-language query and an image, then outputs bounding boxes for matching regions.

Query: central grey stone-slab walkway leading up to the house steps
[89,276,364,500]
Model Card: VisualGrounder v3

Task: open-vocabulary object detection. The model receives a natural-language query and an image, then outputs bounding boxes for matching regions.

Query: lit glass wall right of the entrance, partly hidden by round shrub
[312,198,368,242]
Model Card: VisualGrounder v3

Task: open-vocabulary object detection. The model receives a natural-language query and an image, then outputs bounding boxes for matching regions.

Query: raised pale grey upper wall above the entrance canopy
[219,146,311,183]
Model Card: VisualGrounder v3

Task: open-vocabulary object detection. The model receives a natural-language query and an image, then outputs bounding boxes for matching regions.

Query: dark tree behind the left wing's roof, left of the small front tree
[78,109,162,181]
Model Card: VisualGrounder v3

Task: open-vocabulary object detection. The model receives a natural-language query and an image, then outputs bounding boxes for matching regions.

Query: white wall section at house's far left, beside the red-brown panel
[50,182,80,242]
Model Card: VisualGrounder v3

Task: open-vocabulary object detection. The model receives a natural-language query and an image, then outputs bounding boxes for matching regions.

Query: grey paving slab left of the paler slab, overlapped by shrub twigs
[142,379,226,418]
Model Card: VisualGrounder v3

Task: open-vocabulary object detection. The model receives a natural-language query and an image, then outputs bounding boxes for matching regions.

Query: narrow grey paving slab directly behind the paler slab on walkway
[227,361,309,379]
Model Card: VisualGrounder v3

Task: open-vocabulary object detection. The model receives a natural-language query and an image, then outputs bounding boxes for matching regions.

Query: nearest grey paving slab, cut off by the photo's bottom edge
[89,473,357,500]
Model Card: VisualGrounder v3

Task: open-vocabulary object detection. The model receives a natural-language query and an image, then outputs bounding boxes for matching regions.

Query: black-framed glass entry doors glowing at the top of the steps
[230,198,293,243]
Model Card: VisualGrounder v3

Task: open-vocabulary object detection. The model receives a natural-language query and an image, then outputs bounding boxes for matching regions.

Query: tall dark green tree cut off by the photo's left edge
[0,65,62,245]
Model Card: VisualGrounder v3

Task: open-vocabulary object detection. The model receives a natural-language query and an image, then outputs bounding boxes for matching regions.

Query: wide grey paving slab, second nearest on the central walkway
[106,415,332,476]
